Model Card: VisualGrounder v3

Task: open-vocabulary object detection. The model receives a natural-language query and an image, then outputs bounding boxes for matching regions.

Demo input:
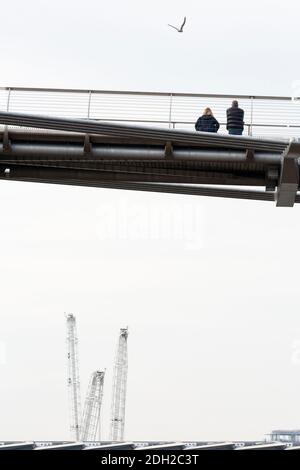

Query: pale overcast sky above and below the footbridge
[0,0,300,440]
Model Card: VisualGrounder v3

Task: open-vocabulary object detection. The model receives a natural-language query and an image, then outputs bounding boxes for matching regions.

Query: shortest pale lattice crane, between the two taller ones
[81,370,105,442]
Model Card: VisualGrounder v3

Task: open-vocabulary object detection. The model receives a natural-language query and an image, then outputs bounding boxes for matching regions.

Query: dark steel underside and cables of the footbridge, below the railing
[0,113,300,206]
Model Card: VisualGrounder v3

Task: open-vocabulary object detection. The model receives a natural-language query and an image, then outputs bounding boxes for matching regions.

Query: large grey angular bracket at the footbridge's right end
[276,141,300,207]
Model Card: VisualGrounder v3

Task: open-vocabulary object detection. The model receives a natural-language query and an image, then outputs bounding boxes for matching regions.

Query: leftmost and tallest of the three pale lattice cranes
[66,313,81,441]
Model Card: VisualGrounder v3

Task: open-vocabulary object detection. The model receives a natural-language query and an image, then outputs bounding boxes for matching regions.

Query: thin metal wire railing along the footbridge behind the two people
[0,87,300,138]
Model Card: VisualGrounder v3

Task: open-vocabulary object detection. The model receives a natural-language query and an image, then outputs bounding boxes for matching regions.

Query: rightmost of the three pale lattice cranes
[110,328,128,441]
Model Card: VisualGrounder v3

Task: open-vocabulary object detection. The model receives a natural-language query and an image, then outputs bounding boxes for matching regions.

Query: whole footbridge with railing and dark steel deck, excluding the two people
[0,88,300,207]
